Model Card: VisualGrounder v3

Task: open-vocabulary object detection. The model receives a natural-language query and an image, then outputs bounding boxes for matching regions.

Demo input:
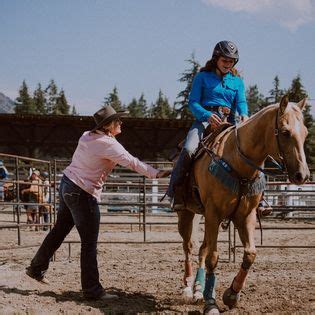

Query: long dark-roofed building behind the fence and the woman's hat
[0,114,192,161]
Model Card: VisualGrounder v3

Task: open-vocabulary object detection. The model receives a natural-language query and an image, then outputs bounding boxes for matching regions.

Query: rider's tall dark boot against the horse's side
[166,149,192,210]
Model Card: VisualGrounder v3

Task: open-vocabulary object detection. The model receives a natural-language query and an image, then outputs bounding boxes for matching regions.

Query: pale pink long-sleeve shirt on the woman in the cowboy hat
[63,131,158,201]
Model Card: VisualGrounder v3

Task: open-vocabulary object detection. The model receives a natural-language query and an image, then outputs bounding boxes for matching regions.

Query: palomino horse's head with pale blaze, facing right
[276,96,310,185]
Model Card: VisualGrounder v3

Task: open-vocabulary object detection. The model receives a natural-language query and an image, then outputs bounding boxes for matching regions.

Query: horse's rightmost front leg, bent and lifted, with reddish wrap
[223,209,256,308]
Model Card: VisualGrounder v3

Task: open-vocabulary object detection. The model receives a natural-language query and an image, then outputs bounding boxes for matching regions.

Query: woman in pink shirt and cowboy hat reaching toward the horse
[26,106,169,300]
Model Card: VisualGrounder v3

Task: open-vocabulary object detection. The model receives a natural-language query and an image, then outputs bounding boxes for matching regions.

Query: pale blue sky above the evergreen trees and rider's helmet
[0,0,315,115]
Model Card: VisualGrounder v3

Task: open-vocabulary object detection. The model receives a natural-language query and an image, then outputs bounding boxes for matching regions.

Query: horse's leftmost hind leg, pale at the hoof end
[177,210,195,299]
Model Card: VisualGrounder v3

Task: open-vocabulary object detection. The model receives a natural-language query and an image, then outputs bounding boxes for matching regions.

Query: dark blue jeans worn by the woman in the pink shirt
[30,176,104,298]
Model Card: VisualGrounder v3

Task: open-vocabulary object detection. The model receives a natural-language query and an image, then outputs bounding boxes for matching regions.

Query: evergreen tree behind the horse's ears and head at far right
[288,75,315,166]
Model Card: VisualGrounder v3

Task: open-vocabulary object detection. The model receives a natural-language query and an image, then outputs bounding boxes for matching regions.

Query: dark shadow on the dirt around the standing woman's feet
[0,285,180,315]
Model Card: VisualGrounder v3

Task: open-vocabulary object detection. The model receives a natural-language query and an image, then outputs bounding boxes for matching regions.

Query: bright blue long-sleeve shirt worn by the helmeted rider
[188,71,248,122]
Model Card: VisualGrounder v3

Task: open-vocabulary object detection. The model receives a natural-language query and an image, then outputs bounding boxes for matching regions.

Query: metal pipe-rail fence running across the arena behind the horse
[0,153,315,262]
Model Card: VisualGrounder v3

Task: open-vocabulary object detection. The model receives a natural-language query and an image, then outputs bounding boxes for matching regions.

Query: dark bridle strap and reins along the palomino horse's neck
[235,107,287,176]
